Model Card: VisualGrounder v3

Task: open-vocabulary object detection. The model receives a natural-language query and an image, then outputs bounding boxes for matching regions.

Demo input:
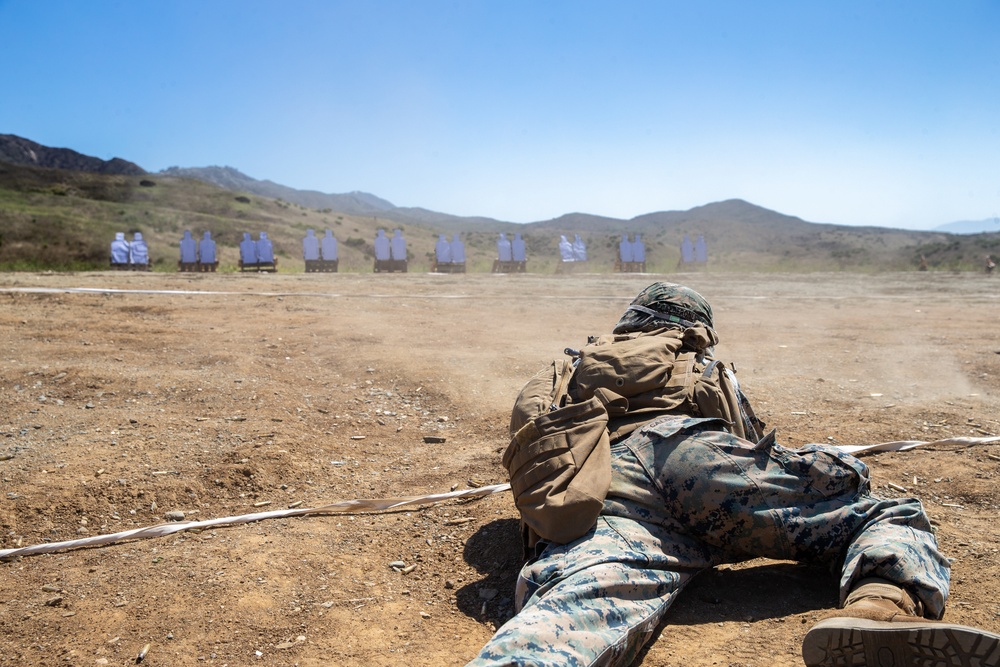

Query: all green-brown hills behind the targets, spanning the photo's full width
[0,161,1000,273]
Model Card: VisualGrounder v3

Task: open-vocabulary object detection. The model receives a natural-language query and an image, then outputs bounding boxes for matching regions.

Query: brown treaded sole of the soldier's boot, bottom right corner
[802,617,1000,667]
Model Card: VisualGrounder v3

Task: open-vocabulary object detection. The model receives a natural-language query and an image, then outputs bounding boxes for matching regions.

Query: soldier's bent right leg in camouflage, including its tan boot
[620,423,1000,667]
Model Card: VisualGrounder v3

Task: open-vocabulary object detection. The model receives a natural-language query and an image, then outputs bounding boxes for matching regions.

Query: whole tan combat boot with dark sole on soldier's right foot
[802,579,1000,667]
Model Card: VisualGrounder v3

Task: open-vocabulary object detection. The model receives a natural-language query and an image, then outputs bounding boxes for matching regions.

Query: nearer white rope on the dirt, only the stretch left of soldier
[0,484,510,560]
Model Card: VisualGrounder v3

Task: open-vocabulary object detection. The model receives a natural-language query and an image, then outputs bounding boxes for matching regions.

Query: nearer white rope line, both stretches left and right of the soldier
[0,436,1000,560]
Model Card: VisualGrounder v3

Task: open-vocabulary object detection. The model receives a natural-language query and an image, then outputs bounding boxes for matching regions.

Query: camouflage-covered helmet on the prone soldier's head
[614,283,713,334]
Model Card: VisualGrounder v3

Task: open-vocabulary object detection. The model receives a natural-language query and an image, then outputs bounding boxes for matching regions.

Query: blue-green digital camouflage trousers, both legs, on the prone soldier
[469,417,949,667]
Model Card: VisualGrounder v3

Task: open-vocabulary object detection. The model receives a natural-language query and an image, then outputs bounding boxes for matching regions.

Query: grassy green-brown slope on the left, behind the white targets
[0,162,592,272]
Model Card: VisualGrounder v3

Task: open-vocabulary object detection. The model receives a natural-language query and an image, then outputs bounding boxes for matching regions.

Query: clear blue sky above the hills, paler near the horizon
[0,0,1000,229]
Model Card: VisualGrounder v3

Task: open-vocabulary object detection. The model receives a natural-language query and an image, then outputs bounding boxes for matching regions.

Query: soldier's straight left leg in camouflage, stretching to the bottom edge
[468,517,712,667]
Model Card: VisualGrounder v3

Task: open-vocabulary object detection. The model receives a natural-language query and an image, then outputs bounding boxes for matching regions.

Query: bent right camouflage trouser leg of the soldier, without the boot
[639,421,949,617]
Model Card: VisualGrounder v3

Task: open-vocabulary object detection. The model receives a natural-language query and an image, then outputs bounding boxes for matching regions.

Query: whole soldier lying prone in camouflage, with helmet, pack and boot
[467,282,1000,667]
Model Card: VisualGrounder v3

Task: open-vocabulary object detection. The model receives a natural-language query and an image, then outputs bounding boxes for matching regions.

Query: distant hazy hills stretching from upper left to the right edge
[154,167,1000,271]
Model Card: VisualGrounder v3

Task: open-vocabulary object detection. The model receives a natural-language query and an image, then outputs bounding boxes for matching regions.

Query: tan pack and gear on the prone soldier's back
[503,324,758,548]
